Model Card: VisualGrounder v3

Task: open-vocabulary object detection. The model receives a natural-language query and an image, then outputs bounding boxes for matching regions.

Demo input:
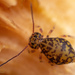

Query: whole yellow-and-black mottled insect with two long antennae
[0,4,75,67]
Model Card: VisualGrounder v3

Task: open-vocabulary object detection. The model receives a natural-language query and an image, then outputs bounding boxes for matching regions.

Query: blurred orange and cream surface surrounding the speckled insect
[0,0,75,75]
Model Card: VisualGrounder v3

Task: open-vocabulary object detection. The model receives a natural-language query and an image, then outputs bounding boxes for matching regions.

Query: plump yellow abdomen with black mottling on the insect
[40,38,75,65]
